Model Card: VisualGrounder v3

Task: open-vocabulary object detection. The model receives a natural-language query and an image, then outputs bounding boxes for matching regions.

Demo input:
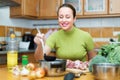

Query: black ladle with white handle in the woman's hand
[36,27,56,61]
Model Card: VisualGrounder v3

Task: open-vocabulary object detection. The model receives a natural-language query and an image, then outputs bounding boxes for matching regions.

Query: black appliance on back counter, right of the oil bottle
[22,32,35,49]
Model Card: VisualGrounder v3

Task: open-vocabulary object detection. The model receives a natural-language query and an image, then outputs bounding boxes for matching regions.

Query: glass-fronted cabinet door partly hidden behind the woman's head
[63,0,83,16]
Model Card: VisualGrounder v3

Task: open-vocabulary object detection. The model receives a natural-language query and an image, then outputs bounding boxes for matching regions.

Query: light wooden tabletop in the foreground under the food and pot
[0,66,94,80]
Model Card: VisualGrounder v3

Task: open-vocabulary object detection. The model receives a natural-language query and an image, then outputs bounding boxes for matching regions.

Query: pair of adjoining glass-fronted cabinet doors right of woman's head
[63,0,108,17]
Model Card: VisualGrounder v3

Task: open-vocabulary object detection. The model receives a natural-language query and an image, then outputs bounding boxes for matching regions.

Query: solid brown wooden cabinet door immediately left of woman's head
[39,0,61,19]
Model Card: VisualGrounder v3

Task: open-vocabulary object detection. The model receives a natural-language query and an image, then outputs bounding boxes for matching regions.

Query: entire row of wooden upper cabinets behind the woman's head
[10,0,120,19]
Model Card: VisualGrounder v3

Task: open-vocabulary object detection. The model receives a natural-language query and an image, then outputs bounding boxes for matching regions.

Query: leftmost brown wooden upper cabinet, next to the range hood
[10,0,39,18]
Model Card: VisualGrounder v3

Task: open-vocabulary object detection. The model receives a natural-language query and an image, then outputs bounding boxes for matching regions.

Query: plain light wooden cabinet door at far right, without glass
[109,0,120,14]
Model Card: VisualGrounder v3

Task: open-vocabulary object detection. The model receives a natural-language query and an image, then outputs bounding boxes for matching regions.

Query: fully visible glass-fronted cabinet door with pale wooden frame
[84,0,108,15]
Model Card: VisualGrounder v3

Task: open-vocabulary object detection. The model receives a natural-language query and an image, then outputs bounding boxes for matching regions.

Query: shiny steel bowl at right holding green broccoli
[92,63,120,80]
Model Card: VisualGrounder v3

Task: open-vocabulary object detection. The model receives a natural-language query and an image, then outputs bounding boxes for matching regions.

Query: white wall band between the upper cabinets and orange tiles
[0,7,120,28]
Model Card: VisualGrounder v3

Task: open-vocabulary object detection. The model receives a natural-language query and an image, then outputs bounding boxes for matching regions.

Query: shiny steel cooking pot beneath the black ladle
[39,59,66,77]
